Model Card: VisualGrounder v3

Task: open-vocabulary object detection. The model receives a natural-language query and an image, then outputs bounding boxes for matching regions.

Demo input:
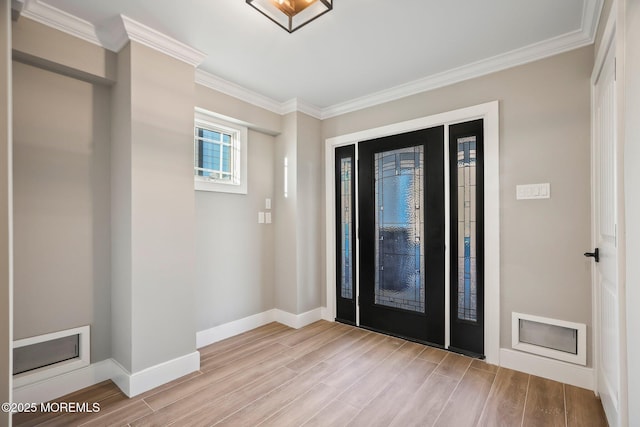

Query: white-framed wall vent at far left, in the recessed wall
[13,326,91,388]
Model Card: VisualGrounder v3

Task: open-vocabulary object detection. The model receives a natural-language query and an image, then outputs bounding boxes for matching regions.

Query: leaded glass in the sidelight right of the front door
[457,136,478,322]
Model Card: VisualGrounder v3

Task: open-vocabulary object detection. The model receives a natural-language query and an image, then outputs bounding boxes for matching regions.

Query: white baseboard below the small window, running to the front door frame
[196,307,333,348]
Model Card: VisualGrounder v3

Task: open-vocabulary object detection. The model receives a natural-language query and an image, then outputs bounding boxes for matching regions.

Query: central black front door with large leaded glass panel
[358,126,445,346]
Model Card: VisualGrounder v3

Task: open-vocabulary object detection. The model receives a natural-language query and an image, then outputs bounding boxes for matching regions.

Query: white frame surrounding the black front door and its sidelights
[324,101,500,365]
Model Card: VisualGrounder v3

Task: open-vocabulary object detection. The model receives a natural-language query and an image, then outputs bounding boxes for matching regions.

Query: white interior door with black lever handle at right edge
[592,38,621,426]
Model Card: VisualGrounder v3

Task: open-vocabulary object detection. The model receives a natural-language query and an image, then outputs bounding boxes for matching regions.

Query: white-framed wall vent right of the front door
[511,312,587,365]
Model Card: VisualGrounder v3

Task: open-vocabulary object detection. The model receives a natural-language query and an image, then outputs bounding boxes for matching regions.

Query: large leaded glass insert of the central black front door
[374,146,425,313]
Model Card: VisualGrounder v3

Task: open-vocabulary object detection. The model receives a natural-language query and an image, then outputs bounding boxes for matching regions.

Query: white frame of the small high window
[193,108,249,194]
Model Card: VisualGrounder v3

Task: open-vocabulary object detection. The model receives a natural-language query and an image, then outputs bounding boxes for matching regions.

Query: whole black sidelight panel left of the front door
[335,145,356,325]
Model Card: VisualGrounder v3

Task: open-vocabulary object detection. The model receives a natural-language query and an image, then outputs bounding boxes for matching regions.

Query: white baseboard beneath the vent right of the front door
[500,348,595,390]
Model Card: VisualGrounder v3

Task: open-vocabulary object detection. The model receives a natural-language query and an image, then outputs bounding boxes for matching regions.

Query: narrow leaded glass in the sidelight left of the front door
[340,157,353,299]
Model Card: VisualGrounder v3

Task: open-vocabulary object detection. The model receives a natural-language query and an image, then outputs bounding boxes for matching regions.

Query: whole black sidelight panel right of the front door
[449,120,484,356]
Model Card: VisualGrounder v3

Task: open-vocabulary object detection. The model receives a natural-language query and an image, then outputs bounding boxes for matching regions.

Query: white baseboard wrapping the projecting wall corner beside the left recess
[111,351,200,397]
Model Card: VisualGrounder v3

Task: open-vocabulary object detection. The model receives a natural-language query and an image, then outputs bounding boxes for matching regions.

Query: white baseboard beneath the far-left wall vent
[13,359,116,403]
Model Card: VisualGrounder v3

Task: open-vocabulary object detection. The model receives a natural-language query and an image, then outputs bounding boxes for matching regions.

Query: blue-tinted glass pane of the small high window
[195,127,235,181]
